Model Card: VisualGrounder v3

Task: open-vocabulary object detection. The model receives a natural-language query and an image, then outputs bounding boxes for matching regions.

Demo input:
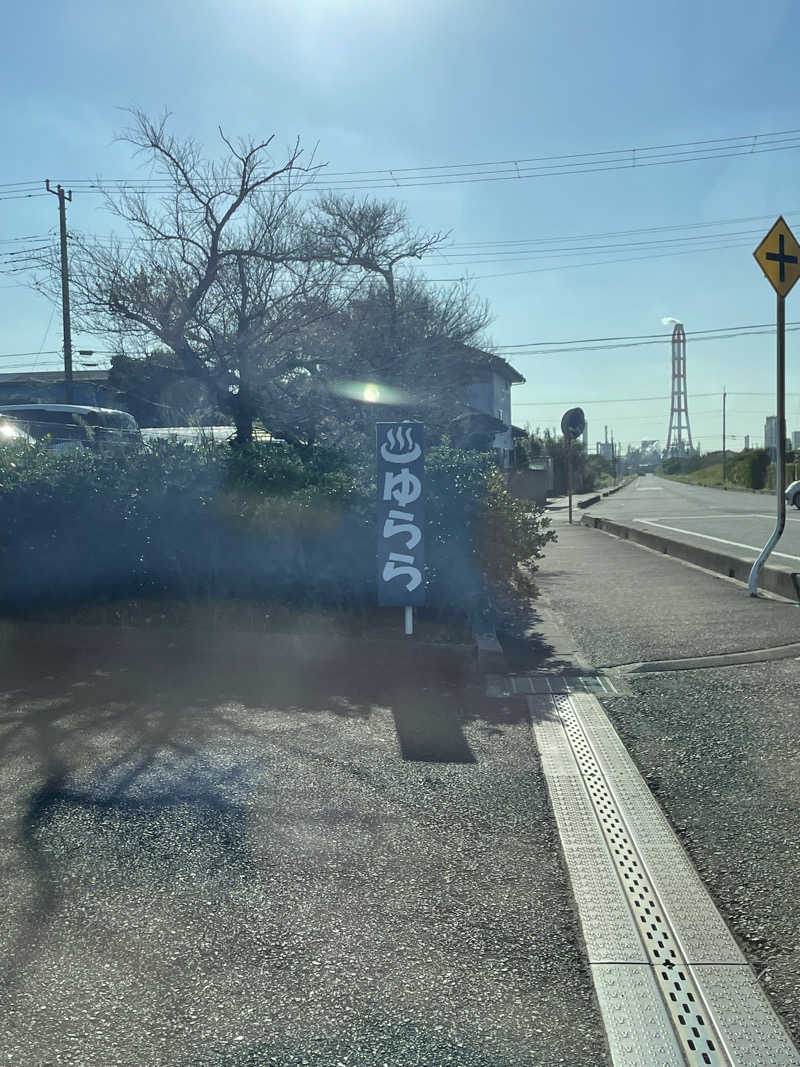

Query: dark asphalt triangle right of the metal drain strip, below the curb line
[603,660,800,1044]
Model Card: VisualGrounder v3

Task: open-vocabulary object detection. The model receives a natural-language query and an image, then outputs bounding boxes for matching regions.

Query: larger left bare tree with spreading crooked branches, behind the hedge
[41,111,347,443]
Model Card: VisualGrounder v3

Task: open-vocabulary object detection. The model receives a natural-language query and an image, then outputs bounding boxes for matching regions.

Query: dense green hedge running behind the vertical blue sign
[0,442,553,615]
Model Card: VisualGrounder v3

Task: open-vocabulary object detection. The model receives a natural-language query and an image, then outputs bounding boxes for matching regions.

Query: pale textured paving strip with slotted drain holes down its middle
[528,685,800,1067]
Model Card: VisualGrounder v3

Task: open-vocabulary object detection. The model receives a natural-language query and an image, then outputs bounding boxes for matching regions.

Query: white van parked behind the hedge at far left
[0,403,142,452]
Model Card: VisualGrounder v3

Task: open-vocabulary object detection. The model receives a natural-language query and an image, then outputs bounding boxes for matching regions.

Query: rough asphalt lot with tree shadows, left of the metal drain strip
[0,631,606,1067]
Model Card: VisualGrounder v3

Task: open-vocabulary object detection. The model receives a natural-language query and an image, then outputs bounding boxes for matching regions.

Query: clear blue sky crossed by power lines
[0,0,800,449]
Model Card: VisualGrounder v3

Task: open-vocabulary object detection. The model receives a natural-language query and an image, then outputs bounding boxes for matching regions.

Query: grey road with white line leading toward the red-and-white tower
[591,475,800,570]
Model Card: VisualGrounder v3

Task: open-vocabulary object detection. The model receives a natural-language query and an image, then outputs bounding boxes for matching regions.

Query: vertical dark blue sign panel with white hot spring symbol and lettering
[377,423,425,606]
